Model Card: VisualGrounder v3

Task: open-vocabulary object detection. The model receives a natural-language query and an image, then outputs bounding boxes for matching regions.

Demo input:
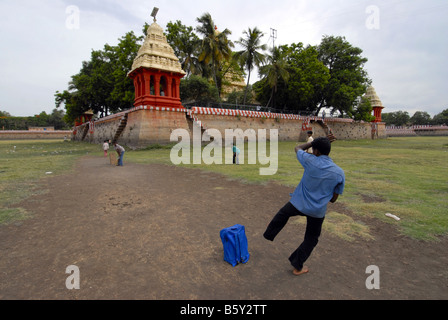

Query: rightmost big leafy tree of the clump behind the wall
[317,36,371,116]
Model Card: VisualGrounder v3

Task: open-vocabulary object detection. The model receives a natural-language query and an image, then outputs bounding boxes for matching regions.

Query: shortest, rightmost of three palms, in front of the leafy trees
[260,47,289,107]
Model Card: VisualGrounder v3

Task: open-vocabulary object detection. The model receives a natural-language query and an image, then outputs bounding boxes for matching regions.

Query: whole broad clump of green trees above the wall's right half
[254,36,372,121]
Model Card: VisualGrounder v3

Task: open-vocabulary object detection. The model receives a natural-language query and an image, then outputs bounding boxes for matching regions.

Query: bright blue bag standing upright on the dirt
[219,224,249,266]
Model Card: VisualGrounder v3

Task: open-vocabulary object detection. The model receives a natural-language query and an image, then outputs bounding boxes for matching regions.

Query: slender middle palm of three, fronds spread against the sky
[236,27,266,104]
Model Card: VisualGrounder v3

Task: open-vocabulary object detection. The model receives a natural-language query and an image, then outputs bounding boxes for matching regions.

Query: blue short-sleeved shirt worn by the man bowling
[290,150,345,218]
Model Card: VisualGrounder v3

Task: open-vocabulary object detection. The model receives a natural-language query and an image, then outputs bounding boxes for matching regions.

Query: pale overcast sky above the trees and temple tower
[0,0,448,116]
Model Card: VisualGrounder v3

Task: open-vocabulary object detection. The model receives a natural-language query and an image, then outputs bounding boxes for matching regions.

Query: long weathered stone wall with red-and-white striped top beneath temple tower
[72,106,386,149]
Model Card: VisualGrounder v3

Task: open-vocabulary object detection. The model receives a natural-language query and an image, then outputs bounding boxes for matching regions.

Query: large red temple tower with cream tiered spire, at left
[128,18,186,108]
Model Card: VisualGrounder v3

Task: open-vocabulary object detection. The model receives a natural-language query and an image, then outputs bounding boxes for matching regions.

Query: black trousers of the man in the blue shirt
[263,202,325,270]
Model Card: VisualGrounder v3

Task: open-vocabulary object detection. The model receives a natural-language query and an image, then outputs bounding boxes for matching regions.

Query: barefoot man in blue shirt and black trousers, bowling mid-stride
[263,134,345,275]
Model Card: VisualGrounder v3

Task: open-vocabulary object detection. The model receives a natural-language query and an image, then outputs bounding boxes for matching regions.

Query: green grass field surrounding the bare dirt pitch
[0,137,448,240]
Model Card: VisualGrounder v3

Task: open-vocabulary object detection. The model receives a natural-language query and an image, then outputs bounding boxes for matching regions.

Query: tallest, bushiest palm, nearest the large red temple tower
[196,13,233,95]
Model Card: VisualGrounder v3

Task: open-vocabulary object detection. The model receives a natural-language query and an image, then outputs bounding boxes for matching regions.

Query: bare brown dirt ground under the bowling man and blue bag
[0,157,448,300]
